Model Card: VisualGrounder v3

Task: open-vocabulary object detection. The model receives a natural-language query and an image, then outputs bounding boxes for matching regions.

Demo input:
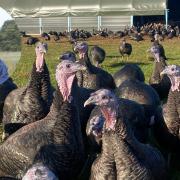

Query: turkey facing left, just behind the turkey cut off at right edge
[149,45,171,100]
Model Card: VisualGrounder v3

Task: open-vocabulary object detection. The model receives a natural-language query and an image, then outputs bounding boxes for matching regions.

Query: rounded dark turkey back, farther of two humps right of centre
[113,64,145,87]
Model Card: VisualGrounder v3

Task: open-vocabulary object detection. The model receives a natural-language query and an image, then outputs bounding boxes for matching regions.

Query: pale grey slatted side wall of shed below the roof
[15,16,132,34]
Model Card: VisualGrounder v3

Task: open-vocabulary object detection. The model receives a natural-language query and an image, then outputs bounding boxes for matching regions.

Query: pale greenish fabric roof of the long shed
[0,0,166,17]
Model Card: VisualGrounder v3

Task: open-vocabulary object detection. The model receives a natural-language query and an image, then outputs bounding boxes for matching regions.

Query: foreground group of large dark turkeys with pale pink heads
[0,35,180,180]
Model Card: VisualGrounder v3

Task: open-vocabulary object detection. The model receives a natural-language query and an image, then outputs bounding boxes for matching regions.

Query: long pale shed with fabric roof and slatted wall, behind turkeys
[1,0,168,34]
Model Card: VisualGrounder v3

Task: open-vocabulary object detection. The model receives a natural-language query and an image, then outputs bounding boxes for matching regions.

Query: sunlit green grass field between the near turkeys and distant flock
[0,38,180,180]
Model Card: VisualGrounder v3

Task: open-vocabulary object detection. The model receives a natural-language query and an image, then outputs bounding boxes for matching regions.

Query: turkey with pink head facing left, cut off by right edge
[161,65,180,138]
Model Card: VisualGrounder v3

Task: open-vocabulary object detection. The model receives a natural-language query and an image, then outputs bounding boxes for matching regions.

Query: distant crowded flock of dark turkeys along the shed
[20,23,180,46]
